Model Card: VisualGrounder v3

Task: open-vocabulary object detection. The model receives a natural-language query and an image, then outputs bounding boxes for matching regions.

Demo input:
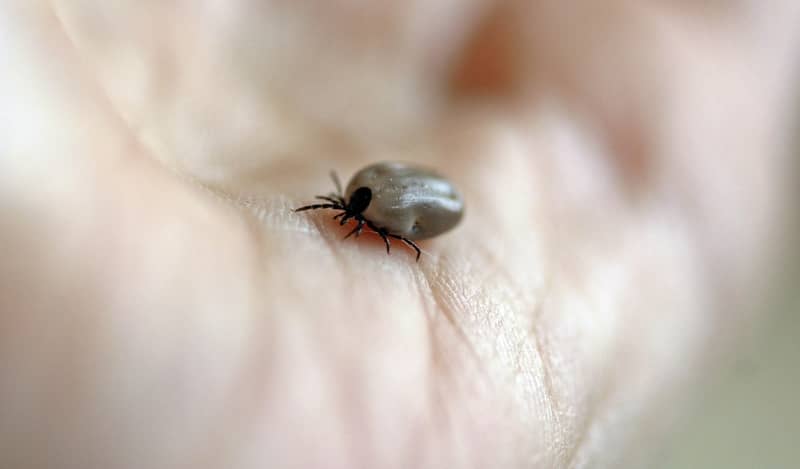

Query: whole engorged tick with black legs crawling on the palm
[295,162,464,261]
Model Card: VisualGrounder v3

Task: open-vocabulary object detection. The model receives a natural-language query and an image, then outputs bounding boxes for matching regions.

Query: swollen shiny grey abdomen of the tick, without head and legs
[345,162,464,241]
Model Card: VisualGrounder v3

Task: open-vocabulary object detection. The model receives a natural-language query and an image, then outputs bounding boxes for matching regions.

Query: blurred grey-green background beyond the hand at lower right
[651,125,800,469]
